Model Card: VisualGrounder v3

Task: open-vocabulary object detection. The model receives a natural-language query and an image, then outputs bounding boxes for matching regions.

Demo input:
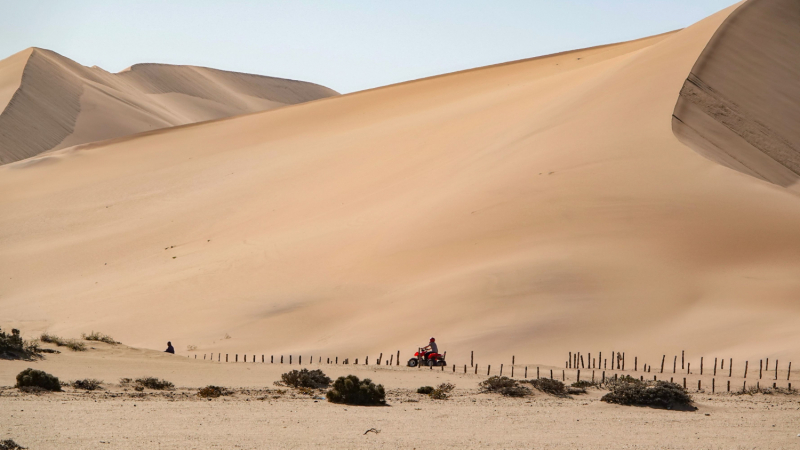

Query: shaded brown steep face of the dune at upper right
[673,0,800,186]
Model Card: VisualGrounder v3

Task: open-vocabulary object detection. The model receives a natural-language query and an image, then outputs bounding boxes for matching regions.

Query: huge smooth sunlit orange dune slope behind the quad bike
[0,0,800,364]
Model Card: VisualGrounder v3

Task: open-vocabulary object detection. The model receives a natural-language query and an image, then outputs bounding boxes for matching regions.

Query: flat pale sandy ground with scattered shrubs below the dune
[0,343,800,449]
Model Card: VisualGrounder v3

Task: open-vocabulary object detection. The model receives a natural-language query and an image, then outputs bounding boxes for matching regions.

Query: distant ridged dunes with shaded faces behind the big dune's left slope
[0,48,336,164]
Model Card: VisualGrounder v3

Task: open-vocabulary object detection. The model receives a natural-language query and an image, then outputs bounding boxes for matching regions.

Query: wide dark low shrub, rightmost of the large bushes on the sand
[601,377,692,409]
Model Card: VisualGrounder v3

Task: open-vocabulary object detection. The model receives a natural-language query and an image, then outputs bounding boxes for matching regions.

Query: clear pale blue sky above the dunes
[0,0,735,93]
